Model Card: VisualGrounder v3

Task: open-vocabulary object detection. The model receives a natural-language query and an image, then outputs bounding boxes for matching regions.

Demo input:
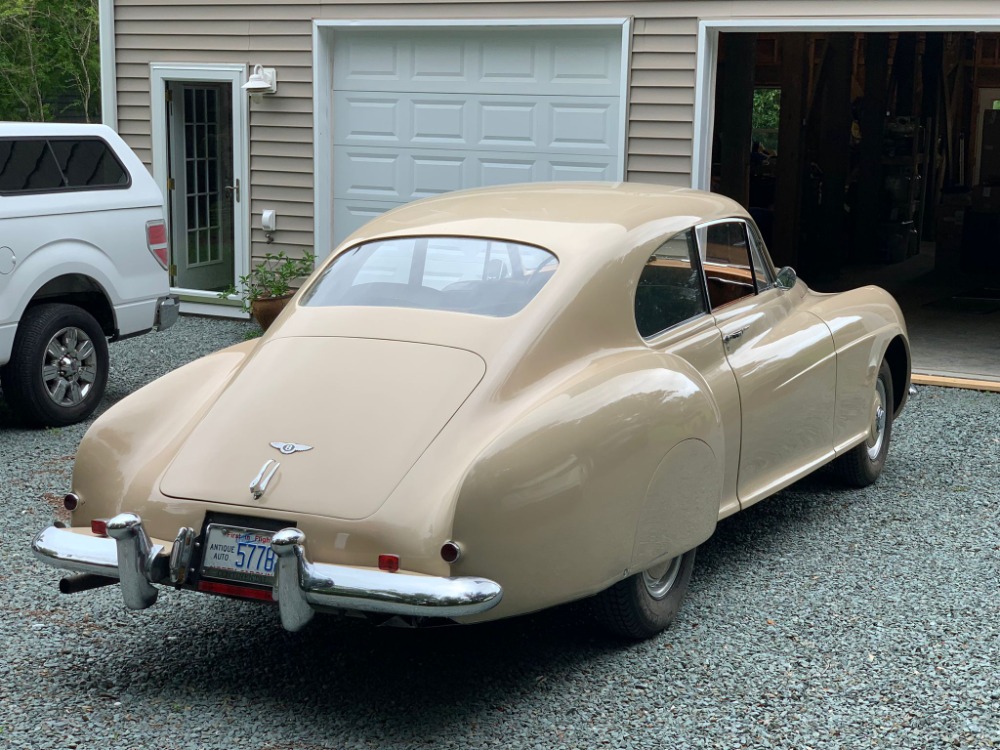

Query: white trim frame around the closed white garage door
[312,17,632,259]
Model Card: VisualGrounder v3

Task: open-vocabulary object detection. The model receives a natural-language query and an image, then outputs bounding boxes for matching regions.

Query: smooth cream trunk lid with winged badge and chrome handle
[160,337,486,519]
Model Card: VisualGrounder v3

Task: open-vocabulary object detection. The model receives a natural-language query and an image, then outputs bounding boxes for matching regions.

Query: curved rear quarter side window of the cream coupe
[635,229,707,338]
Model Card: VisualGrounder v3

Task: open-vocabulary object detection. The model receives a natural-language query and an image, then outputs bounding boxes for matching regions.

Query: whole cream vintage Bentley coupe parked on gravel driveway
[33,183,910,638]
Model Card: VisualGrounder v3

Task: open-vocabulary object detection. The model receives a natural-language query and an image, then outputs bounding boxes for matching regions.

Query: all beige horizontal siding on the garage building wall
[115,0,995,255]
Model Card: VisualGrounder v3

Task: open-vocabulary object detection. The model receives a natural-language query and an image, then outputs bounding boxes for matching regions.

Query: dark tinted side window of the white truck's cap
[0,137,130,195]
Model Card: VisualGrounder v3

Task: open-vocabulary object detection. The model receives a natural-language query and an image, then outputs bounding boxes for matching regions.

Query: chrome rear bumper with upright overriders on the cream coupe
[31,513,503,631]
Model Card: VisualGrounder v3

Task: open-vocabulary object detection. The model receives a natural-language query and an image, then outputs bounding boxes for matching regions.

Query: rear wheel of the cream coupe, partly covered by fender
[593,550,695,640]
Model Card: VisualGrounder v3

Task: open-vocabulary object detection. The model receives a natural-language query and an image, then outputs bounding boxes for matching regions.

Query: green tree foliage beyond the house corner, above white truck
[0,0,100,122]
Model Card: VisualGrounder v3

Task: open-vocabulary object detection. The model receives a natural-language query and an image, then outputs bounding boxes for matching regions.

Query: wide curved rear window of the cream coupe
[302,237,558,317]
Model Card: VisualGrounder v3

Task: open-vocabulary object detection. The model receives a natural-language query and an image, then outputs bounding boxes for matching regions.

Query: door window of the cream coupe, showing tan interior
[699,221,757,310]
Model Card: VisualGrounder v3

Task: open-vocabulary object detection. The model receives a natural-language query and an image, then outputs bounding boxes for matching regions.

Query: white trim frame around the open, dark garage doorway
[691,16,1000,190]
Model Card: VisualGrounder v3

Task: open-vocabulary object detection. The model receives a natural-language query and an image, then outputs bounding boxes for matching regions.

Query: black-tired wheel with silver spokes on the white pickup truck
[0,303,108,427]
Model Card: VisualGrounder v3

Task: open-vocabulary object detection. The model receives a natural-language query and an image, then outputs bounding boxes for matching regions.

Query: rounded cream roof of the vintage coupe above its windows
[342,182,747,259]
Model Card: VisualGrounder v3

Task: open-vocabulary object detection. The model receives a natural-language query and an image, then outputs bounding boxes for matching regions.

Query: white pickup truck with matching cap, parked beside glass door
[0,123,178,426]
